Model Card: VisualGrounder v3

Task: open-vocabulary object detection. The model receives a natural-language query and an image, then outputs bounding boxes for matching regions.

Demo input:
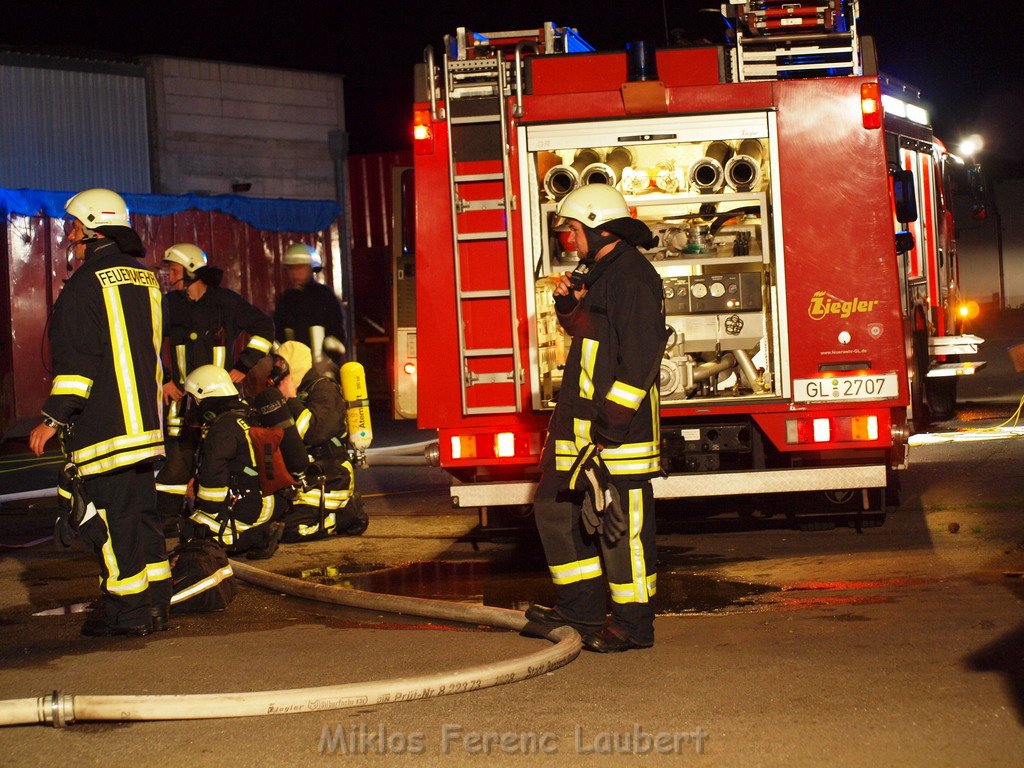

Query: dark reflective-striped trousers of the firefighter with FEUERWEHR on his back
[79,463,171,627]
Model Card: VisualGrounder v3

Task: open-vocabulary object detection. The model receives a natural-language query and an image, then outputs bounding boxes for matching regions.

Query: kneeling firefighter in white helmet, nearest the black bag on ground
[181,365,305,560]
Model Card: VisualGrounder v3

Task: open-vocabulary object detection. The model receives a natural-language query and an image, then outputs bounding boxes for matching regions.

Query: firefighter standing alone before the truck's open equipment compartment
[526,183,667,652]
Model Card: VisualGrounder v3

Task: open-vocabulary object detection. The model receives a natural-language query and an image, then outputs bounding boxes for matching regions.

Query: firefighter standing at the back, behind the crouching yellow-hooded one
[273,243,345,360]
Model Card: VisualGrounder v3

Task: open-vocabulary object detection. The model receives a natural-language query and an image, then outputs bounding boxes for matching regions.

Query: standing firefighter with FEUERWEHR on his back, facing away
[30,189,171,636]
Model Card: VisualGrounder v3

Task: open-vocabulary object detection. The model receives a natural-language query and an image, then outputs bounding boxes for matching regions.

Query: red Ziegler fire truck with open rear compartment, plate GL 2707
[405,0,984,524]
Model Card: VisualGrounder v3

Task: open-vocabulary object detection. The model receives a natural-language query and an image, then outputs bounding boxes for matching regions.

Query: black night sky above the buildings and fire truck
[6,0,1024,175]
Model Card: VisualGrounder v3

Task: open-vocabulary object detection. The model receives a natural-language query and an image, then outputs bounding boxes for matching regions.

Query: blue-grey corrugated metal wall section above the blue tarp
[0,60,151,194]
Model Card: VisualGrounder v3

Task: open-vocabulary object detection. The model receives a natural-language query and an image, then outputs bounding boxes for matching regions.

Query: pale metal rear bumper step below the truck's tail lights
[451,464,886,507]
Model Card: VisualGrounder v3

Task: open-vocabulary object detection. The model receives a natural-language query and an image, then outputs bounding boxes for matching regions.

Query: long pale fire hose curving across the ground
[0,561,582,728]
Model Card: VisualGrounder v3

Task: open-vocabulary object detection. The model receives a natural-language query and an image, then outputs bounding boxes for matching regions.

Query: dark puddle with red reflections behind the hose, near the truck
[297,560,779,615]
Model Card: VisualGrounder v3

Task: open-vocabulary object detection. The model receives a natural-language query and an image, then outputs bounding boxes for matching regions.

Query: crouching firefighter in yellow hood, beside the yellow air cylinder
[274,341,369,543]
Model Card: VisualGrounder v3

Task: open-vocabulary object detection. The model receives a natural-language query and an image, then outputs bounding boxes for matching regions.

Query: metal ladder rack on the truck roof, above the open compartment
[722,0,874,83]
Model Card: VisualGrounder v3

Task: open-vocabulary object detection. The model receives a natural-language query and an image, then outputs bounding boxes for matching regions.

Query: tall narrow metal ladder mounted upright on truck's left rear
[442,26,553,416]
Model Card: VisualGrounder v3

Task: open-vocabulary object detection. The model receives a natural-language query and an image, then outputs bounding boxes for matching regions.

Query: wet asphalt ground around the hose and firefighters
[0,323,1024,766]
